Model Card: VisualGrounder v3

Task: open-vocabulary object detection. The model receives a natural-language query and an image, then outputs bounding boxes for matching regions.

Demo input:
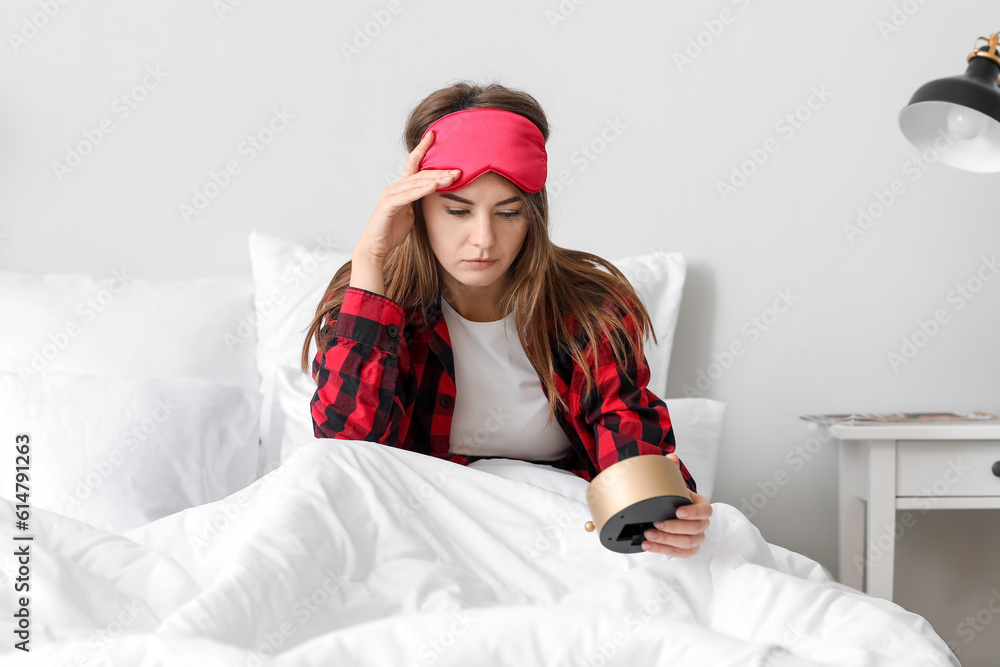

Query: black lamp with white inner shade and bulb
[899,33,1000,172]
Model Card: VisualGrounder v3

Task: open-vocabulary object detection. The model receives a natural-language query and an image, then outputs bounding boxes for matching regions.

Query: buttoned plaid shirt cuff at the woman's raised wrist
[333,287,406,354]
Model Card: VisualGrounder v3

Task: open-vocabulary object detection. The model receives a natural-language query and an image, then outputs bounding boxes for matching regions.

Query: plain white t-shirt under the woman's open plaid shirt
[441,298,571,461]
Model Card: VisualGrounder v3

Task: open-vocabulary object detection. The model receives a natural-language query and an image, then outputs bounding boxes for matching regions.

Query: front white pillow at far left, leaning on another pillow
[0,370,261,533]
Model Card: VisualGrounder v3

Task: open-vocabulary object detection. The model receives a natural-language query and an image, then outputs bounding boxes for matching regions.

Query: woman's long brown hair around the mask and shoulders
[302,82,656,424]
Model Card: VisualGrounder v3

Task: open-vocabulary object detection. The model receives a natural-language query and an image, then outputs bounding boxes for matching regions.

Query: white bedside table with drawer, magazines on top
[819,421,1000,600]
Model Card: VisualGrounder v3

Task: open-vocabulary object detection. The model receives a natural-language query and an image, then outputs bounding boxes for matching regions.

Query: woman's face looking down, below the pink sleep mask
[422,172,528,305]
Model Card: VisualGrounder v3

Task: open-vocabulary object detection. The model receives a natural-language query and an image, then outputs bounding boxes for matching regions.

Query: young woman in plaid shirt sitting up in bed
[302,83,712,557]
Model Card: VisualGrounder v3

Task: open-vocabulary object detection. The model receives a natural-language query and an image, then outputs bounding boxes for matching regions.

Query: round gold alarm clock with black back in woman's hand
[584,454,691,553]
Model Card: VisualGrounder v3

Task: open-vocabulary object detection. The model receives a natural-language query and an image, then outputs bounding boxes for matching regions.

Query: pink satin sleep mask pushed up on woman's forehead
[418,108,547,192]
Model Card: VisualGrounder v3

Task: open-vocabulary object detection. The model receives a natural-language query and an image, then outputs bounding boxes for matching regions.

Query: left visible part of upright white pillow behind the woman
[249,231,351,460]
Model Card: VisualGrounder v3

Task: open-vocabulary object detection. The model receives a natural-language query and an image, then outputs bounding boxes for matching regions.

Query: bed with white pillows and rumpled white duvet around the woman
[0,232,959,667]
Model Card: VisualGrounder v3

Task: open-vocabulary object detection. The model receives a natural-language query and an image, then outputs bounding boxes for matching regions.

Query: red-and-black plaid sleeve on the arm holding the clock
[574,306,697,491]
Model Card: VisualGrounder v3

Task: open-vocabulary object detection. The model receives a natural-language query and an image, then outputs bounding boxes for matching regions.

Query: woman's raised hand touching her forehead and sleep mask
[355,131,460,263]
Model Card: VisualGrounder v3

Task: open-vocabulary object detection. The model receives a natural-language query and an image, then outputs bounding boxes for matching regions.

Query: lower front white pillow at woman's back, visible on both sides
[266,366,726,498]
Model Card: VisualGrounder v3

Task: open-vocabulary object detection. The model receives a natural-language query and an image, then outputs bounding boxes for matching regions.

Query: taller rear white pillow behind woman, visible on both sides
[249,231,686,468]
